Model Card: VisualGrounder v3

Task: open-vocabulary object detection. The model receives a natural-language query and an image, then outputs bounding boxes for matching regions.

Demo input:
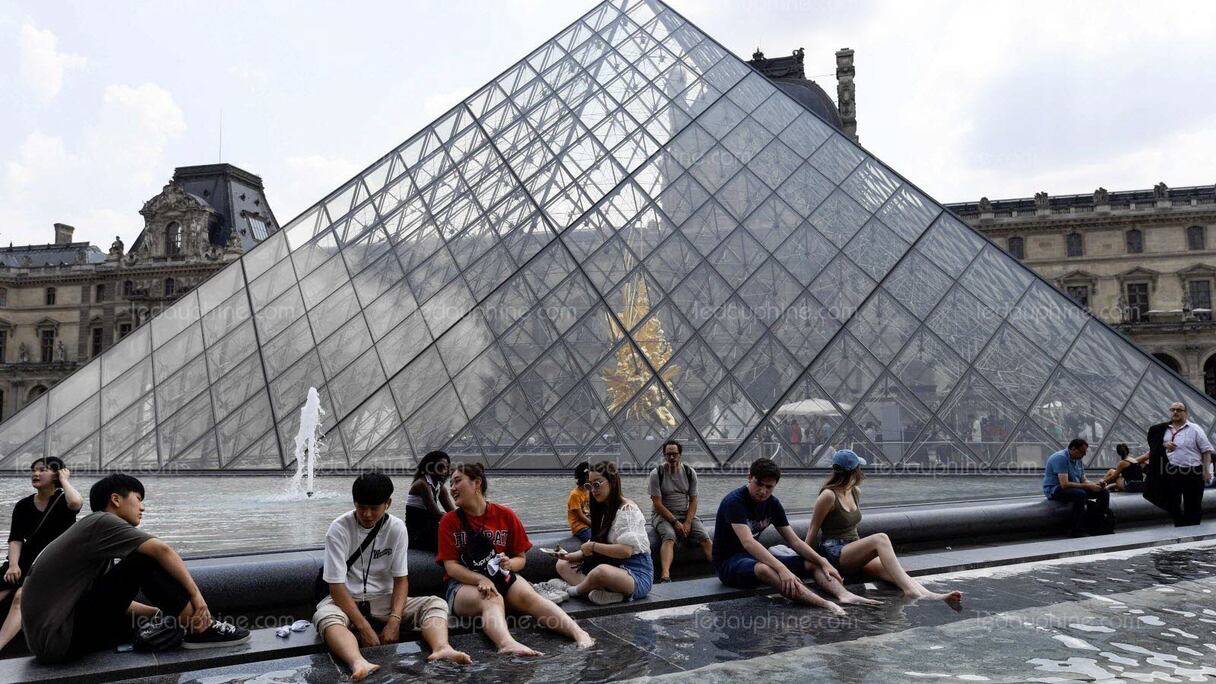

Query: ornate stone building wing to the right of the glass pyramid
[947,183,1216,396]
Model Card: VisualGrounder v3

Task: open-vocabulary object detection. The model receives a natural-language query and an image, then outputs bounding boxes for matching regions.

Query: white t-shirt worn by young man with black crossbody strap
[322,511,410,600]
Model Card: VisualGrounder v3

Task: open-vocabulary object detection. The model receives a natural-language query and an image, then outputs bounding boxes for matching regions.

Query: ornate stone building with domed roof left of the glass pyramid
[0,164,278,419]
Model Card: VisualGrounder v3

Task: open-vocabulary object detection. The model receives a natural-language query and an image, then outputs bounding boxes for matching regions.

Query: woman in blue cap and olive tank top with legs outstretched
[806,449,963,601]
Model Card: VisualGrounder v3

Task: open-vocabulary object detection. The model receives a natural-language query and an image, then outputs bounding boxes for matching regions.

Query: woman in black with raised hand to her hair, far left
[0,456,84,650]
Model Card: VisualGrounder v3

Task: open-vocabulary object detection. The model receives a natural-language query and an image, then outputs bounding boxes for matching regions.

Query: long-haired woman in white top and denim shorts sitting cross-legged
[557,461,654,605]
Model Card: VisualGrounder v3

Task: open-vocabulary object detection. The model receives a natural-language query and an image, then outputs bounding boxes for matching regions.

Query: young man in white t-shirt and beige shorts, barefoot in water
[313,472,472,682]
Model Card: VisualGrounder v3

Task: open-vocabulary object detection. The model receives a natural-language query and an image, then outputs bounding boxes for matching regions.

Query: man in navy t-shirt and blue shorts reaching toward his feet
[713,459,878,615]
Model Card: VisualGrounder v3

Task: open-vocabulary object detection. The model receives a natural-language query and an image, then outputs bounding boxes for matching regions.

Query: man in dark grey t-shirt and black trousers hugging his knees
[18,473,249,662]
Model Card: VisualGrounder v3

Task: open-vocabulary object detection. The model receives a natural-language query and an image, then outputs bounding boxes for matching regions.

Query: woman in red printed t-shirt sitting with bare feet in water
[435,464,595,656]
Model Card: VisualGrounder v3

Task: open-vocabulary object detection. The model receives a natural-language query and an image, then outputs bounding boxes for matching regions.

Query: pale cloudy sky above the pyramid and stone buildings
[0,0,1216,248]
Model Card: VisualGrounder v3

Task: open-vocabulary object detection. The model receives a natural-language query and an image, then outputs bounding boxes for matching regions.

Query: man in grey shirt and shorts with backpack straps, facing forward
[647,439,714,582]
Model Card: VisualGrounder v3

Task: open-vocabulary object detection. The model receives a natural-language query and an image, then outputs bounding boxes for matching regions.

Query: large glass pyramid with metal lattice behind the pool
[0,0,1216,470]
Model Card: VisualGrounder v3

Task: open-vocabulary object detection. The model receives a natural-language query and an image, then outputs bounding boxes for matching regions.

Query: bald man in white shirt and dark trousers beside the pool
[1165,402,1212,527]
